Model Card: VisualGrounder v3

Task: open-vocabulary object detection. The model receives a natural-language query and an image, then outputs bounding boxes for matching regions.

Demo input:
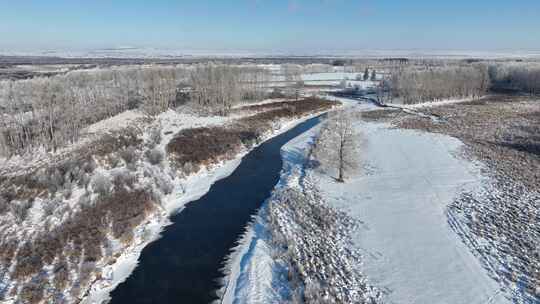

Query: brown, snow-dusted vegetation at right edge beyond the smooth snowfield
[363,95,540,303]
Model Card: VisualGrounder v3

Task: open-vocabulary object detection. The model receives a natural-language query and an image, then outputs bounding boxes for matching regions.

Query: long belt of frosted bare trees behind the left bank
[0,64,268,156]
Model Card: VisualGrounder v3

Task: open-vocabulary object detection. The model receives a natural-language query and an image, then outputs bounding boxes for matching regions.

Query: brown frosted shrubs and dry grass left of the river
[0,99,334,302]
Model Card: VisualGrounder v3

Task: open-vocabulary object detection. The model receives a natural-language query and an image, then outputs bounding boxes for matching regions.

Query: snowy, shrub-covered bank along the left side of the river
[0,97,338,303]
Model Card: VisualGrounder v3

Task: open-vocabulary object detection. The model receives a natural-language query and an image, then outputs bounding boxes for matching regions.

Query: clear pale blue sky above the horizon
[0,0,540,51]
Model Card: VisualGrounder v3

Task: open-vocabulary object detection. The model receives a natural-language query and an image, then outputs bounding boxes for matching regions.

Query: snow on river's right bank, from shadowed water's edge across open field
[228,98,511,303]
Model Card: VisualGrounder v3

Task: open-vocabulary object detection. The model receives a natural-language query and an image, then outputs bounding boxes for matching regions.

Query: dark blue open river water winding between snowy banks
[111,117,319,304]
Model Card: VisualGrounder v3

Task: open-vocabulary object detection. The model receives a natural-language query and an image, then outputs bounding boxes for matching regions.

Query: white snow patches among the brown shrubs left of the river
[0,96,336,303]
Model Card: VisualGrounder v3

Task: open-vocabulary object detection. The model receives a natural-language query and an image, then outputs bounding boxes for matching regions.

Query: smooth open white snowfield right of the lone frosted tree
[319,117,508,303]
